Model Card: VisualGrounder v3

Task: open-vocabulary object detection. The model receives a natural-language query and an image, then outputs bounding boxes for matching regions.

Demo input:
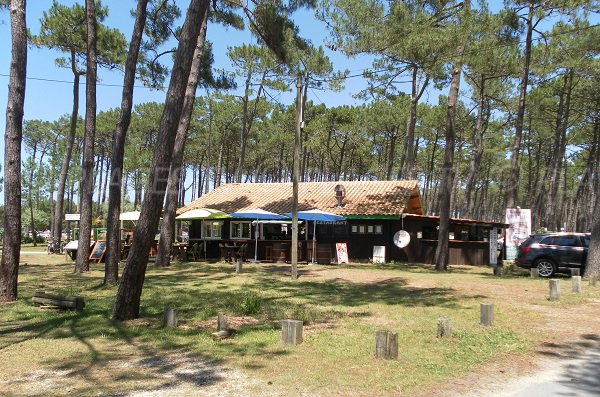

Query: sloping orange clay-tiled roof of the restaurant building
[177,181,422,215]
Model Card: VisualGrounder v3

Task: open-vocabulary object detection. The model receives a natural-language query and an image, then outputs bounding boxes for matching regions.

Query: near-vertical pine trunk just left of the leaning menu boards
[75,0,97,273]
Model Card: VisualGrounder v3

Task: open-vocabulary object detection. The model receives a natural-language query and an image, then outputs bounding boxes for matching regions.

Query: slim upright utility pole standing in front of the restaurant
[292,72,303,280]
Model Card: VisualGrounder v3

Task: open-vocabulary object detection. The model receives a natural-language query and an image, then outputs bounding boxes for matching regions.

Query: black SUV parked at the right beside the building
[515,233,590,277]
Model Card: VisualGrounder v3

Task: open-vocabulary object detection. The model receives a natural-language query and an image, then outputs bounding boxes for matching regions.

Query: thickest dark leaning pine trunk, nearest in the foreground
[112,0,210,320]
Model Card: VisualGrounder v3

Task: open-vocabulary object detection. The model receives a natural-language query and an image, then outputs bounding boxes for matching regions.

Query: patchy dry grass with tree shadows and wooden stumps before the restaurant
[0,255,600,395]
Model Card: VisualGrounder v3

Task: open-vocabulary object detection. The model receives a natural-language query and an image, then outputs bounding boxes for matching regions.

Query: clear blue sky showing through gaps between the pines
[0,0,370,139]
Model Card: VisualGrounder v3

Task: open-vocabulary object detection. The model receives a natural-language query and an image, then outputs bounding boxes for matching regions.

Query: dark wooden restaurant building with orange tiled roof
[177,181,506,265]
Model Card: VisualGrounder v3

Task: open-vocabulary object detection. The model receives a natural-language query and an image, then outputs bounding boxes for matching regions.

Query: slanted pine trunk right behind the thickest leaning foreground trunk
[156,8,208,267]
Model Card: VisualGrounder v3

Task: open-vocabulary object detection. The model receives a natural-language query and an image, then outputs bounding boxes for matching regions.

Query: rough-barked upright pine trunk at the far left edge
[0,0,27,302]
